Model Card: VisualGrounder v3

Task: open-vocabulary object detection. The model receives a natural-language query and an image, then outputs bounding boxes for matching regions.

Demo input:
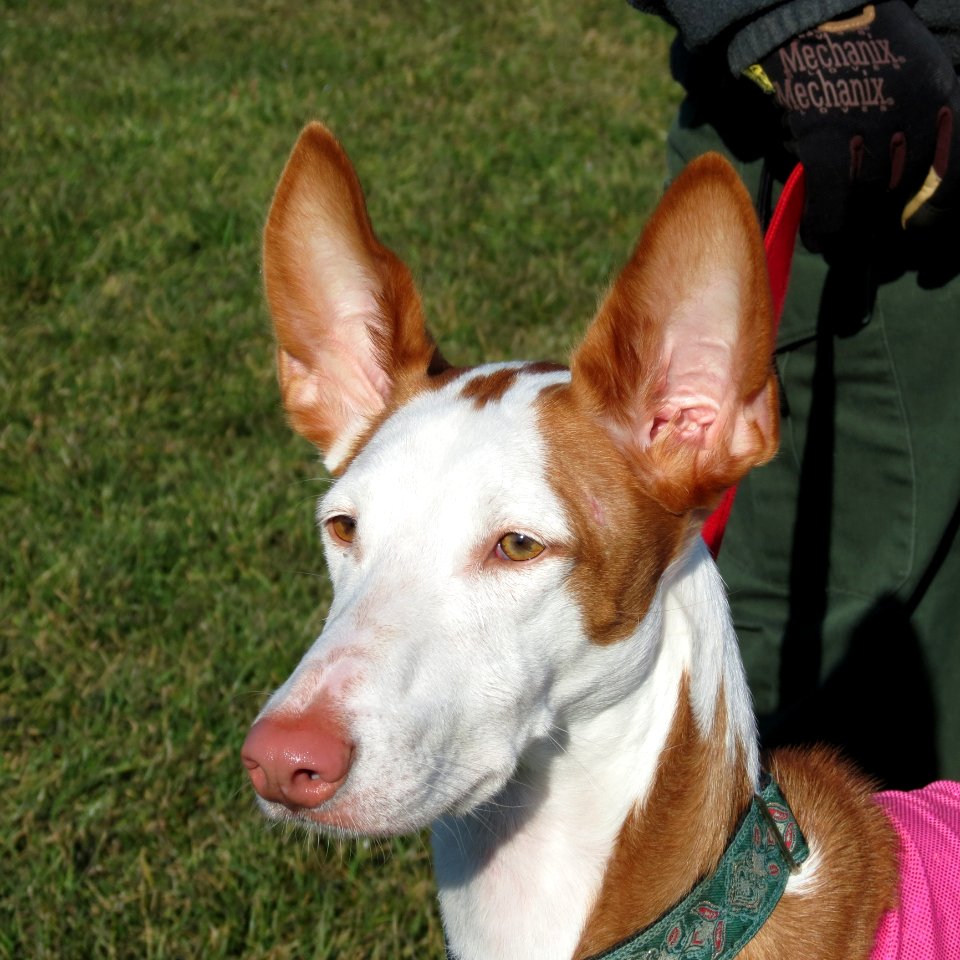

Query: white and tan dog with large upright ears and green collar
[242,123,960,960]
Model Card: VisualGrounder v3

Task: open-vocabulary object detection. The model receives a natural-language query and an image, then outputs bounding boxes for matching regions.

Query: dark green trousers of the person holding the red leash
[668,69,960,788]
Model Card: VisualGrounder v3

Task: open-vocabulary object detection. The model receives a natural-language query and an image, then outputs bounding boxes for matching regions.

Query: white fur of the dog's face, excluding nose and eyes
[267,366,588,833]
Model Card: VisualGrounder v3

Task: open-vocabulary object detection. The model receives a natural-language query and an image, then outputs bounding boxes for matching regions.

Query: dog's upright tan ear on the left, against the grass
[263,123,442,472]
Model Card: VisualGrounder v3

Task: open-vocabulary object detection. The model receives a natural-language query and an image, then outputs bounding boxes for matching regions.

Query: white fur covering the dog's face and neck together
[251,365,758,960]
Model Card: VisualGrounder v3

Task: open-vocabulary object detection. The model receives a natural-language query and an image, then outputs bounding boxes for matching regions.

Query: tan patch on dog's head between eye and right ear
[539,384,692,644]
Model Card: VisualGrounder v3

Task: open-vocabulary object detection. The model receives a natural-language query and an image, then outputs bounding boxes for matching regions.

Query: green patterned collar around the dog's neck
[590,776,810,960]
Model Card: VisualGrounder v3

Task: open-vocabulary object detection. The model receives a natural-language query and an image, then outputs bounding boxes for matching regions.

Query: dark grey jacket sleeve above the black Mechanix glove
[628,0,960,74]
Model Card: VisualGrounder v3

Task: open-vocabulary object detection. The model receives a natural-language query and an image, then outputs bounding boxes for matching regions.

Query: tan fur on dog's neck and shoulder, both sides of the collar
[574,728,898,960]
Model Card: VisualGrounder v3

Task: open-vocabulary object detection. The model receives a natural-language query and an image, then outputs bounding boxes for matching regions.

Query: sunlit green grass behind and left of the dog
[0,0,677,960]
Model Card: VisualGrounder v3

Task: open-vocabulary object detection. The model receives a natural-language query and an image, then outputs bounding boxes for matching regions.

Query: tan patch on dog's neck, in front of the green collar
[574,677,752,960]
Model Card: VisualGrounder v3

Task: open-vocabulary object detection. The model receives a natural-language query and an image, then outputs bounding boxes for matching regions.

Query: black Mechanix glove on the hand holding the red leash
[746,0,960,250]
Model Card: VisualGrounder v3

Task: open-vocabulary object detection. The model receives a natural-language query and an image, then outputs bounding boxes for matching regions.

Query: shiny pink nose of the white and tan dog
[241,713,353,808]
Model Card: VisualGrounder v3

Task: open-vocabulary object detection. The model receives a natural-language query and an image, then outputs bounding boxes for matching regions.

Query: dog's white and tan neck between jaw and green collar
[433,542,758,960]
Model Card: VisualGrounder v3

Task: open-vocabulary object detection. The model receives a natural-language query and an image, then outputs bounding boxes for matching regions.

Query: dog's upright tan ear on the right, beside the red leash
[571,154,778,512]
